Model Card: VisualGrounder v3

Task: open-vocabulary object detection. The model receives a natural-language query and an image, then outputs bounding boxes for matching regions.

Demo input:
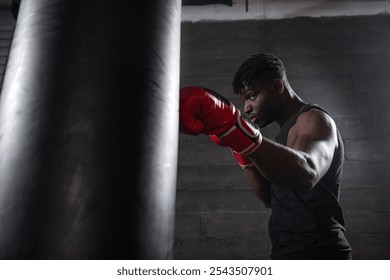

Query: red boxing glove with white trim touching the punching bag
[180,86,262,154]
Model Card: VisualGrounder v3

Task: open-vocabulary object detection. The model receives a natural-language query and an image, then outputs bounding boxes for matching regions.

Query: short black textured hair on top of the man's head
[232,53,287,94]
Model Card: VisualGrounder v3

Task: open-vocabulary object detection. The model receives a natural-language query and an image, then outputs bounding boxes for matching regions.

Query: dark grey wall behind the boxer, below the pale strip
[175,15,390,259]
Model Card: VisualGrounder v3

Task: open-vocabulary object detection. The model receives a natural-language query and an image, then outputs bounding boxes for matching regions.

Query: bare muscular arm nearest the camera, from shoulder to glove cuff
[248,110,337,192]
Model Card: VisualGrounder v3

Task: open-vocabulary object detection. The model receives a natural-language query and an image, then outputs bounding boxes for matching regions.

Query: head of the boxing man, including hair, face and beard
[232,53,290,127]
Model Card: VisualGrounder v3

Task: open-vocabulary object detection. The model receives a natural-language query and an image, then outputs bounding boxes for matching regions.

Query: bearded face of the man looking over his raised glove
[240,83,278,127]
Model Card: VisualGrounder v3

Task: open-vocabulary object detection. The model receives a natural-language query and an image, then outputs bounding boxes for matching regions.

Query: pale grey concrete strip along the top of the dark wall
[182,0,390,22]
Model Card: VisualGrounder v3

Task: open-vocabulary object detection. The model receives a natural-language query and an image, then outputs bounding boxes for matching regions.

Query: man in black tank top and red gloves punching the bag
[180,54,351,259]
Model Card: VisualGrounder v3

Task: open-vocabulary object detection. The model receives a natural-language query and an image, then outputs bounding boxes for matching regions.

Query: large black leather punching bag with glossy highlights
[0,0,181,259]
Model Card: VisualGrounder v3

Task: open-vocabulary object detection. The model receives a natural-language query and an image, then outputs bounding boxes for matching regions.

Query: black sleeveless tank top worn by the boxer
[269,104,351,259]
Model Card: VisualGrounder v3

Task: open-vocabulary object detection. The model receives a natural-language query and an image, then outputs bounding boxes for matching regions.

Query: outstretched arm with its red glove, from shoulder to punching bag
[180,87,337,195]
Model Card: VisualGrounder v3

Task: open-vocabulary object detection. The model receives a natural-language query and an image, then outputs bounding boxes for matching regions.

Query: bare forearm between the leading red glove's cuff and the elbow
[248,138,316,192]
